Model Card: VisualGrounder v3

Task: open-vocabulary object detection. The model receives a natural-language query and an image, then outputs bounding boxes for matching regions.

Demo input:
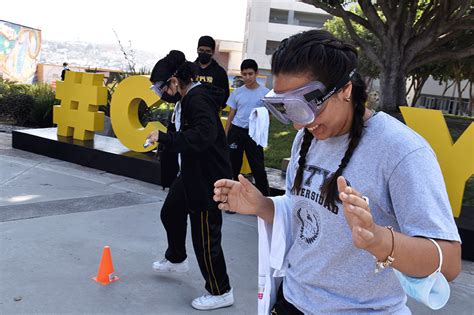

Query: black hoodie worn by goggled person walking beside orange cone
[159,84,232,211]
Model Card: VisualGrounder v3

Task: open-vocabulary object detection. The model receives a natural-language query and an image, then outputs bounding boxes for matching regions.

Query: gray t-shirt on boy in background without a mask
[227,85,269,128]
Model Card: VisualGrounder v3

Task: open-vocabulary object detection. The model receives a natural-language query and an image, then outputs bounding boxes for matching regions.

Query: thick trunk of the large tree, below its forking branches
[380,65,407,112]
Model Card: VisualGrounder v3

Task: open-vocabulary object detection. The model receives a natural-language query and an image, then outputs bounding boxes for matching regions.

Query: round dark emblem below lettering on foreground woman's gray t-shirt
[293,201,321,247]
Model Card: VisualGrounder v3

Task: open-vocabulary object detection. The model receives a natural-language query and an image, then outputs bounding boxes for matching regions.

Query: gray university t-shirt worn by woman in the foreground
[283,112,460,314]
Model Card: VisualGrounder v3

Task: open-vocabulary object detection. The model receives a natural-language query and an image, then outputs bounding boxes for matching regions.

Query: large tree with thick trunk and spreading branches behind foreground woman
[303,0,474,111]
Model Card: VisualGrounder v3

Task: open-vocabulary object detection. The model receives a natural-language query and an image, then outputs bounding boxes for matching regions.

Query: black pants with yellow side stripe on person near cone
[161,176,230,295]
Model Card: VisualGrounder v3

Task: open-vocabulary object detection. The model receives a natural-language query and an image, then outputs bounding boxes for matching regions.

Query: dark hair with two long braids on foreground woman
[272,30,367,208]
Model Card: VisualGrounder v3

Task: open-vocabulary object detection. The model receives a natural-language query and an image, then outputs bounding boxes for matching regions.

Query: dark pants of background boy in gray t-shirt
[227,125,268,196]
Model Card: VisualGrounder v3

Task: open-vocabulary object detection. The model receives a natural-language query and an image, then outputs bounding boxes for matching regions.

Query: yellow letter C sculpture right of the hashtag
[110,76,166,152]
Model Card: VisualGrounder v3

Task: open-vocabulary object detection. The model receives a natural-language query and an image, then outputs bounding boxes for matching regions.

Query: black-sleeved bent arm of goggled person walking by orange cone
[158,95,220,152]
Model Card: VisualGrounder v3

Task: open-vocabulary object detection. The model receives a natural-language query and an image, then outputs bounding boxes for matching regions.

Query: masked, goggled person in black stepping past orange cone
[148,50,234,310]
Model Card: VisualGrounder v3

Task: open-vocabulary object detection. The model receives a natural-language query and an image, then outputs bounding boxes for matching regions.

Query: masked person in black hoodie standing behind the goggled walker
[196,35,229,108]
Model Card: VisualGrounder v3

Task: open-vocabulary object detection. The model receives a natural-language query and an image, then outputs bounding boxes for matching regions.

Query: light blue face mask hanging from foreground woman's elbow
[393,238,451,310]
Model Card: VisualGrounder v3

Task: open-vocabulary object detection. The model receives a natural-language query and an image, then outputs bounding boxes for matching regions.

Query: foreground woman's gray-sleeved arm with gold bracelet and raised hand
[338,148,461,281]
